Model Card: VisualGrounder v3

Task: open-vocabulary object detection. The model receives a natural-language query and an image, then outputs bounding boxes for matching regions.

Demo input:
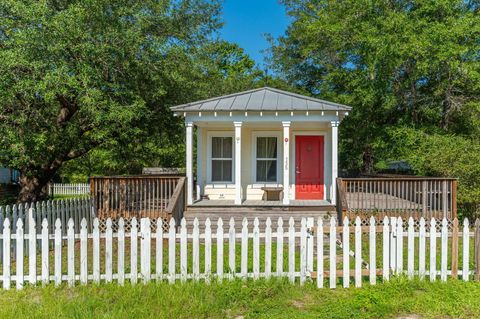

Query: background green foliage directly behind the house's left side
[59,40,264,181]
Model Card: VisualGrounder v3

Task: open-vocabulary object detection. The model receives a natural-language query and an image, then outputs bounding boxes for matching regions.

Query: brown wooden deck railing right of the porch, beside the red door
[337,177,457,219]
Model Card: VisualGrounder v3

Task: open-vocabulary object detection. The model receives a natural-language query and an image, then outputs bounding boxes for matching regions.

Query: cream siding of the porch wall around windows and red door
[197,121,332,200]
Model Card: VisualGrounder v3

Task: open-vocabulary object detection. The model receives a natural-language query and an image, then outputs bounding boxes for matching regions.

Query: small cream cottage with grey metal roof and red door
[171,87,351,206]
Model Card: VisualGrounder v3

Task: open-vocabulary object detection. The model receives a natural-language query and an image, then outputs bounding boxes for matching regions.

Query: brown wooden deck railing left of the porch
[90,175,185,219]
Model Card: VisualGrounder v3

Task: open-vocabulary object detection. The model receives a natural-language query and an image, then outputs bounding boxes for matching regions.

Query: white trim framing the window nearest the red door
[251,131,283,188]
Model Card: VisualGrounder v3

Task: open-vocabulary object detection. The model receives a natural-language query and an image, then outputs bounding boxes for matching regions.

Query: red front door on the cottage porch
[295,135,324,199]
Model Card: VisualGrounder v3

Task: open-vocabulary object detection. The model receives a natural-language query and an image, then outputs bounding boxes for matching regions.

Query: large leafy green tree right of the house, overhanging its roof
[271,0,480,171]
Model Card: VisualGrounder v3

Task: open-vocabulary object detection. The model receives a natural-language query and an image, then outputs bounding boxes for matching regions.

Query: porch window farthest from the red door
[212,137,233,182]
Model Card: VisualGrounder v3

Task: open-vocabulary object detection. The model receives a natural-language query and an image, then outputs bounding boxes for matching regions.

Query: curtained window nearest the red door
[256,137,277,182]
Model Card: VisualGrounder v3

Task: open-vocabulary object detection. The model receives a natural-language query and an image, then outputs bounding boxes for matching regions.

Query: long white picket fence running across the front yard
[0,214,480,289]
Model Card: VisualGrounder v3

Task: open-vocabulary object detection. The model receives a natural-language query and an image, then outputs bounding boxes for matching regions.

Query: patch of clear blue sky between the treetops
[220,0,289,68]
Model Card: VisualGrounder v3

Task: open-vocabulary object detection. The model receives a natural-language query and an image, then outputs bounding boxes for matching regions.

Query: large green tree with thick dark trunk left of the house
[0,0,225,201]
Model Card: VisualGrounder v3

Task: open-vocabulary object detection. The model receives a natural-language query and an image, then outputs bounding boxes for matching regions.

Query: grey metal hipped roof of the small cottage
[170,87,351,112]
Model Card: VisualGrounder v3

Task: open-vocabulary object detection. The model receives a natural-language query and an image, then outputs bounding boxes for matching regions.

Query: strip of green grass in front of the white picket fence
[0,278,480,318]
